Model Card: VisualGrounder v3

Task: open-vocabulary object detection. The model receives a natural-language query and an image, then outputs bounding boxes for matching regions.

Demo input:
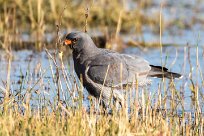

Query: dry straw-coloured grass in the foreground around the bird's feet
[0,45,204,135]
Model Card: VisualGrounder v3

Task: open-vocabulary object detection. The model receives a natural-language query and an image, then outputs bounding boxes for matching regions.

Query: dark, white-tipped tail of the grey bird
[148,65,182,79]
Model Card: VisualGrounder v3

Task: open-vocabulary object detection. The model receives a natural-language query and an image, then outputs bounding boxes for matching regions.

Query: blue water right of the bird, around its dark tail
[124,46,204,111]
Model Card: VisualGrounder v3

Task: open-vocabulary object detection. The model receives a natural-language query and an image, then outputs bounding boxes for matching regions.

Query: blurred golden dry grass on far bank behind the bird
[0,0,203,50]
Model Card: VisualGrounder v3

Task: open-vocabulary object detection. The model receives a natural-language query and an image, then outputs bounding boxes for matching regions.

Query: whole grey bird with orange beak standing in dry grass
[65,32,181,105]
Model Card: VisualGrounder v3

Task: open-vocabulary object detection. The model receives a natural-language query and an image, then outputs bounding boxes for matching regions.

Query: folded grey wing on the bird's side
[87,52,151,87]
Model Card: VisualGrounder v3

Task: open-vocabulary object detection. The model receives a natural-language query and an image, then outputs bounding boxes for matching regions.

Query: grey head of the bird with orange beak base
[63,32,95,52]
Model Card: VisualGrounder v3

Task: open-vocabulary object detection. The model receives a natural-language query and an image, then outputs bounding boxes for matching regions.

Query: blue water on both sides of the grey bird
[0,47,204,111]
